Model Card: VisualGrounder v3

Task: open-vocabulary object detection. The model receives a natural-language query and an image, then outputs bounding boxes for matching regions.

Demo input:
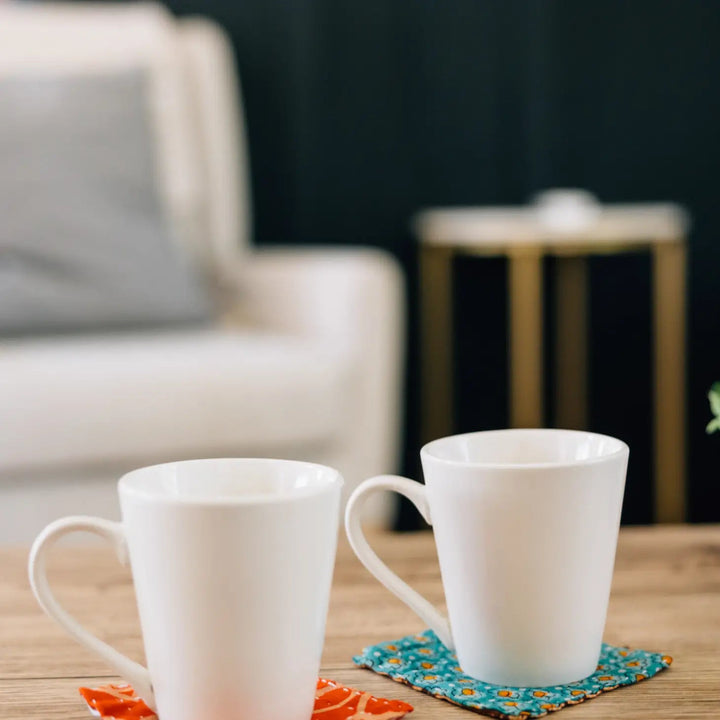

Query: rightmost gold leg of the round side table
[653,241,686,522]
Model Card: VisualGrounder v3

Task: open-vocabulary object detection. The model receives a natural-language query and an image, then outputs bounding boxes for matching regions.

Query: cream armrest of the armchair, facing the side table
[238,247,405,492]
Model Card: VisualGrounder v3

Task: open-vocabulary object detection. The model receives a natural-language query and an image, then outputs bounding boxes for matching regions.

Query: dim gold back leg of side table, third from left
[555,257,588,430]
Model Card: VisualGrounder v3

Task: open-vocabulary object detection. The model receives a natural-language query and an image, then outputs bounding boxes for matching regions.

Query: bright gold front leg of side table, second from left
[508,249,543,428]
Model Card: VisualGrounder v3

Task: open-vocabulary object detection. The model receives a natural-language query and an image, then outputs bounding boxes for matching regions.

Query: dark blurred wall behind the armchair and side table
[0,0,720,540]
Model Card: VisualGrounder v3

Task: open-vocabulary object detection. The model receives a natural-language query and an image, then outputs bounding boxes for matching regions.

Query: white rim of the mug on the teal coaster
[420,428,630,470]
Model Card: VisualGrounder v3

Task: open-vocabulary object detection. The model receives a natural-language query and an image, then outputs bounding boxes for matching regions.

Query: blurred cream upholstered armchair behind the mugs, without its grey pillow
[0,4,404,543]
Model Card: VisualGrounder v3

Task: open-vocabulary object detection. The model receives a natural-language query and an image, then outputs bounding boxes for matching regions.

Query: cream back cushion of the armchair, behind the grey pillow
[0,2,201,252]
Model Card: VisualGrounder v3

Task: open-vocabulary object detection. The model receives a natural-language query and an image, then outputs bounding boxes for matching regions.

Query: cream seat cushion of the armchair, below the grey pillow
[0,329,354,472]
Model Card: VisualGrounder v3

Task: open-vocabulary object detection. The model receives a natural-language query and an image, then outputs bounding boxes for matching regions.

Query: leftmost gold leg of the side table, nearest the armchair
[420,246,453,442]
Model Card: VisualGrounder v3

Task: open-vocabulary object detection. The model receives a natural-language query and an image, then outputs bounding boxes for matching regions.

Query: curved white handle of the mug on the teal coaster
[345,475,455,650]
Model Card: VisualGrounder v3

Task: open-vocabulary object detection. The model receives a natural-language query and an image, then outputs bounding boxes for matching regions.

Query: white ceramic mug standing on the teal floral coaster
[345,430,629,687]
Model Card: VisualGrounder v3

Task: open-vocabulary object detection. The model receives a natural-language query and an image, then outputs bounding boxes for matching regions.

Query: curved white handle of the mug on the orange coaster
[28,515,155,710]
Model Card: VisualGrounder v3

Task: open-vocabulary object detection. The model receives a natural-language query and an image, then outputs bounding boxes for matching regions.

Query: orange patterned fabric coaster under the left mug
[80,678,413,720]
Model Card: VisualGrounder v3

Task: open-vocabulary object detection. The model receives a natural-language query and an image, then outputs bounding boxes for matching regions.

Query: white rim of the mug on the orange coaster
[117,457,344,506]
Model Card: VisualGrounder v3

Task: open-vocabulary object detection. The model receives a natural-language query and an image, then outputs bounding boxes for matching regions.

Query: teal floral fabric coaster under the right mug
[353,630,672,720]
